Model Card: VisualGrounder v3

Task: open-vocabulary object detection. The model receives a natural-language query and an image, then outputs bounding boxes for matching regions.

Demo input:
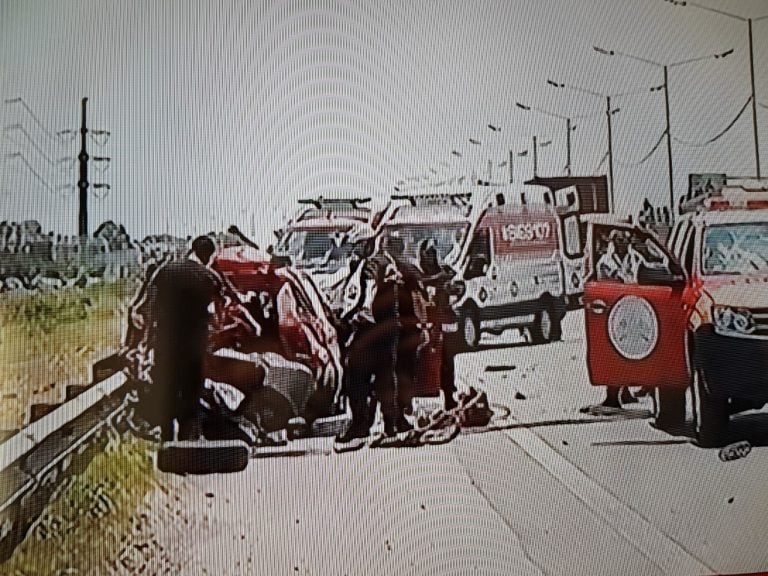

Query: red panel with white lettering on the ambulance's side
[481,212,558,258]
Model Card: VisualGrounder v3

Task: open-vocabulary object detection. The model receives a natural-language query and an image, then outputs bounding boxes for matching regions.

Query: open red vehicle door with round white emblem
[584,223,689,389]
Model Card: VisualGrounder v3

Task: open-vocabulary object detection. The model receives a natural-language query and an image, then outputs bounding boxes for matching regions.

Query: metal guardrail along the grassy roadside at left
[0,370,129,561]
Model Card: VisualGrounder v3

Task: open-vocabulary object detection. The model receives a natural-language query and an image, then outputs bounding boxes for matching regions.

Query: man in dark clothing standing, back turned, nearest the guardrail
[129,236,223,440]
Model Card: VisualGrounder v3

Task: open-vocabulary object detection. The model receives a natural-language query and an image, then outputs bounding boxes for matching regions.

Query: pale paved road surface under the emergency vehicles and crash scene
[142,313,768,575]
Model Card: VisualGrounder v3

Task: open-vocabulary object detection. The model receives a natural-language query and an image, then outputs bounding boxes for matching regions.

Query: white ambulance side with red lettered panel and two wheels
[453,185,583,349]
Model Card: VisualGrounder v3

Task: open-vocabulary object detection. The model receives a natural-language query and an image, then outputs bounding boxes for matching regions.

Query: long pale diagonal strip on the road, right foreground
[504,417,716,575]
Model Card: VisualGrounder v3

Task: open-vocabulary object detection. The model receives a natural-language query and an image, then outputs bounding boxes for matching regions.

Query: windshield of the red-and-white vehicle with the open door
[702,222,768,274]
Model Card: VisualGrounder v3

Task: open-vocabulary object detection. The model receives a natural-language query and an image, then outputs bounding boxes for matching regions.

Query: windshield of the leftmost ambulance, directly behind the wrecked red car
[280,229,353,273]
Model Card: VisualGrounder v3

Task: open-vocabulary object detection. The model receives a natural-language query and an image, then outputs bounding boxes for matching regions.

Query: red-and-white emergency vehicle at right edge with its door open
[585,183,768,446]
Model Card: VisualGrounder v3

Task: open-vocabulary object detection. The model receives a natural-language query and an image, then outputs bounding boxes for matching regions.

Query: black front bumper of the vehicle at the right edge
[694,326,768,402]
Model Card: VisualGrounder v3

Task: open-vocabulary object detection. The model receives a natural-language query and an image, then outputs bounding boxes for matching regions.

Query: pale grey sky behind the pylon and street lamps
[0,0,768,242]
